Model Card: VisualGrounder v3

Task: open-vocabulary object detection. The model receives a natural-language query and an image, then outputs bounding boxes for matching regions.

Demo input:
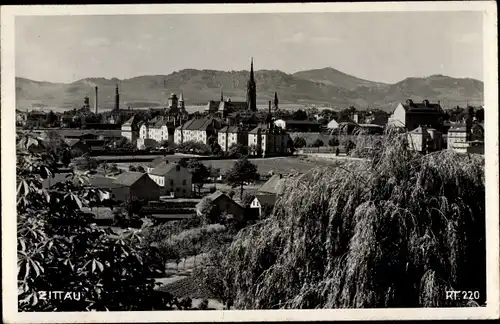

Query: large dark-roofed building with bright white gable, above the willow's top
[388,99,445,131]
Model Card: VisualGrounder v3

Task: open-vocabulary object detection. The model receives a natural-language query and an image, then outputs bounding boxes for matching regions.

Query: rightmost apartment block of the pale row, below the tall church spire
[248,123,290,156]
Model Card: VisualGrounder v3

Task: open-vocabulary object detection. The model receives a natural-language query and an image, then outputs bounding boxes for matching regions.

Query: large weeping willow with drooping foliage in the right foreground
[220,130,486,309]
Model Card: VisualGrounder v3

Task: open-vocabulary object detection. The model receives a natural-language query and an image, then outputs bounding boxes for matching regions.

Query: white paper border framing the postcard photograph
[0,1,500,323]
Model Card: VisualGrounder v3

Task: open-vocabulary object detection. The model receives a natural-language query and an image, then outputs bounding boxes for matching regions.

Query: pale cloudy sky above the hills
[15,11,483,83]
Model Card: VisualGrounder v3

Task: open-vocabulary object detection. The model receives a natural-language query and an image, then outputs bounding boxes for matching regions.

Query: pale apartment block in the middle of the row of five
[174,117,220,145]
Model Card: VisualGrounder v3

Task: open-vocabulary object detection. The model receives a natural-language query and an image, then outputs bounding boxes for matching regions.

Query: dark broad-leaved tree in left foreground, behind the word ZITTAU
[16,134,188,311]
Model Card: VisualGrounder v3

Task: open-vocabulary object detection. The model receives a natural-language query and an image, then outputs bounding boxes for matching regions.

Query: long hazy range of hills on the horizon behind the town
[16,68,483,111]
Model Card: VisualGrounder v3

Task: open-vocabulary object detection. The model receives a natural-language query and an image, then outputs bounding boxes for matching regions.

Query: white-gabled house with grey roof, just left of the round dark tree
[149,161,193,198]
